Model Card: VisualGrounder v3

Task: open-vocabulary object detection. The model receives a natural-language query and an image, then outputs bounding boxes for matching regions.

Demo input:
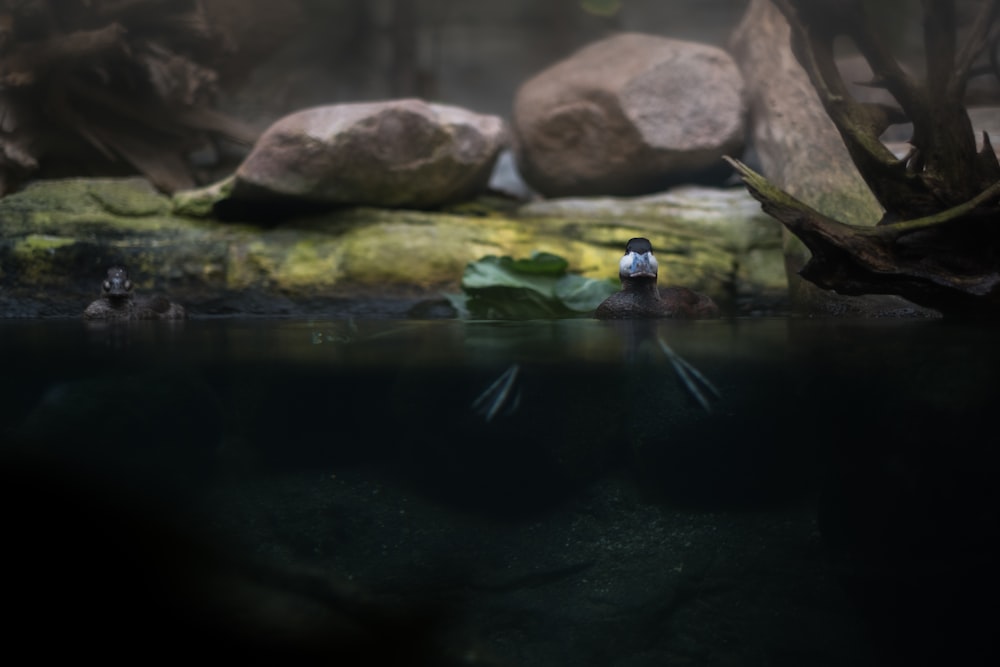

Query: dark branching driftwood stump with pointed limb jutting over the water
[731,0,1000,315]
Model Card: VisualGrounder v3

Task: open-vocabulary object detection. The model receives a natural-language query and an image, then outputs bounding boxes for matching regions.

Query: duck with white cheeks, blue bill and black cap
[594,237,720,320]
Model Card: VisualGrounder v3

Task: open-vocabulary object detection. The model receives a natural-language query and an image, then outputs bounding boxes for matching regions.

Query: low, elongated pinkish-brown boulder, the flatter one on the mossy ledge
[233,99,506,208]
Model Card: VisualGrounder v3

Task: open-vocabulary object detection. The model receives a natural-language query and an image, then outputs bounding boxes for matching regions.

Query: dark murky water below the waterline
[0,319,1000,665]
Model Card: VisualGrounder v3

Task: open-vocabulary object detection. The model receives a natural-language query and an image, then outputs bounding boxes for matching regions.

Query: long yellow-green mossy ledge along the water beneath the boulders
[0,178,786,317]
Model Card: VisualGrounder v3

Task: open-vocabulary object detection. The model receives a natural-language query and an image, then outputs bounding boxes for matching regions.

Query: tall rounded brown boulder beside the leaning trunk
[513,33,747,196]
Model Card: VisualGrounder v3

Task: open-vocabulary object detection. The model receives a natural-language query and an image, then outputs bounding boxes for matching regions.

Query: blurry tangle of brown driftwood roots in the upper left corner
[0,0,274,195]
